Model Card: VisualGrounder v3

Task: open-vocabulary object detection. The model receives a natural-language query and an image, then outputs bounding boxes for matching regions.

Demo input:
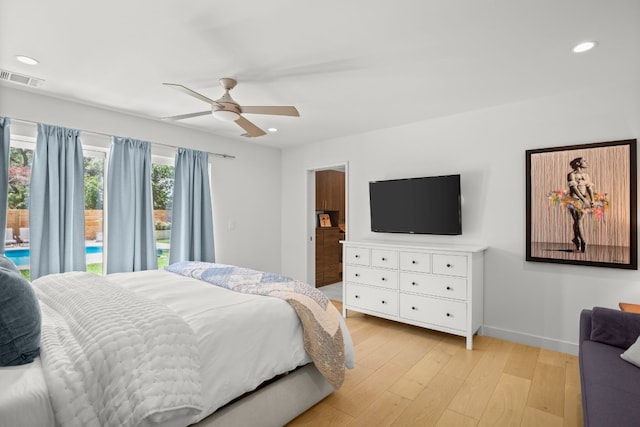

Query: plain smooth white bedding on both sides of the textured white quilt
[0,270,320,427]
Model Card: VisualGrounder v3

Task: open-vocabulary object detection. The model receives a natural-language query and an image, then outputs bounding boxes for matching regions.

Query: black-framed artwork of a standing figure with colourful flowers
[526,139,638,270]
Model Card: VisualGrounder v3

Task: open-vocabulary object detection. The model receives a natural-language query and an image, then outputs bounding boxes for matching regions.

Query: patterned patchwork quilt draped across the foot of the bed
[166,261,345,389]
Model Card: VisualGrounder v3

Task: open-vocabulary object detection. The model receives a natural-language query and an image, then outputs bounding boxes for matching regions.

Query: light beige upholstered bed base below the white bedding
[194,363,334,427]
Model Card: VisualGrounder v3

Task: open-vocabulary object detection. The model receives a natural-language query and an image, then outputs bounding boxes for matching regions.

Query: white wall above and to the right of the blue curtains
[0,85,281,272]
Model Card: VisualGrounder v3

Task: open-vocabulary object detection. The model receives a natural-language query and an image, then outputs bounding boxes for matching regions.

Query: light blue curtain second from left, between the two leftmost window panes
[29,124,86,280]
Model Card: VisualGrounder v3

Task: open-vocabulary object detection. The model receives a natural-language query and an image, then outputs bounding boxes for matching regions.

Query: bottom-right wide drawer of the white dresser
[400,294,467,331]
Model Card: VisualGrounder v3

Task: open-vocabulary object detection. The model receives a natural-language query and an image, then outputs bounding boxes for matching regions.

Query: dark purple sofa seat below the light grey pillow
[580,341,640,426]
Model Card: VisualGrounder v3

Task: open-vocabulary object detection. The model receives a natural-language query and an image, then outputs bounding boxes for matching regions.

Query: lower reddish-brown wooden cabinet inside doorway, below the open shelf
[316,227,342,286]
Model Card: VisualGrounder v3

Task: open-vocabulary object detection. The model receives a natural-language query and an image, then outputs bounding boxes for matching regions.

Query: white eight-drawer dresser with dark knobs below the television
[341,241,486,350]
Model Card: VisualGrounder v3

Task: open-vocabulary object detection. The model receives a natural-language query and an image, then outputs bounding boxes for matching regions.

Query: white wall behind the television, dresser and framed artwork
[282,81,640,353]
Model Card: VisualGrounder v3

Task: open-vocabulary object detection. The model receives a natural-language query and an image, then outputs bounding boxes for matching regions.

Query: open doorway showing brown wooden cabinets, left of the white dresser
[307,163,348,288]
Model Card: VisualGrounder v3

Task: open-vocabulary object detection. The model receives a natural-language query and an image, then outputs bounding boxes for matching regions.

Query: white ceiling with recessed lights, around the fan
[0,0,640,148]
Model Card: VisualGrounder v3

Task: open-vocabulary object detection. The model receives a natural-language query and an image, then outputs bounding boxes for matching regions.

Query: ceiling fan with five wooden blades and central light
[163,78,300,137]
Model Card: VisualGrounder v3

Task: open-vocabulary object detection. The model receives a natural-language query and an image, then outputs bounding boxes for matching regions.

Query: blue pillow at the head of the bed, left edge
[0,255,42,366]
